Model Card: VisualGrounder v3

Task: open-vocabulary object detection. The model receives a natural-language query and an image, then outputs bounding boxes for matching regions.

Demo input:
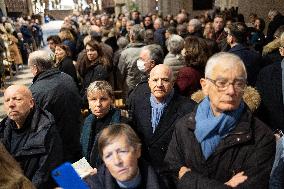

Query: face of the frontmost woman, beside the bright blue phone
[103,135,141,181]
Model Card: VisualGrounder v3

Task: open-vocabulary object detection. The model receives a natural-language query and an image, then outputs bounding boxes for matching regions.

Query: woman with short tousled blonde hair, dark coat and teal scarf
[81,81,127,168]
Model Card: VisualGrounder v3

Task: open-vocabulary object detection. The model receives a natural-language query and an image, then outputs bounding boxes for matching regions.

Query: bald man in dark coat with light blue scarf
[130,64,193,181]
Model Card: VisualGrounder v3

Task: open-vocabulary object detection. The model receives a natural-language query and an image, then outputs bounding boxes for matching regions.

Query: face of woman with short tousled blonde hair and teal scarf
[88,90,113,118]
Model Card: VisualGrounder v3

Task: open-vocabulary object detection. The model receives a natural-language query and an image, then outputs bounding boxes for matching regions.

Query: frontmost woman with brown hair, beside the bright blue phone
[85,124,160,189]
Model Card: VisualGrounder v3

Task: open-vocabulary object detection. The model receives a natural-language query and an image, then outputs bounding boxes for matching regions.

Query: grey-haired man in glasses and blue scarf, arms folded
[165,53,275,189]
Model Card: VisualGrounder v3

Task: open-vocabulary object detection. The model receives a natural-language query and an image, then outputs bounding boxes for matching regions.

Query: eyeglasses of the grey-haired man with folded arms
[206,77,247,91]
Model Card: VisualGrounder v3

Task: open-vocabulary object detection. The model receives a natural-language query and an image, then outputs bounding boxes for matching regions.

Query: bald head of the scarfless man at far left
[4,85,34,128]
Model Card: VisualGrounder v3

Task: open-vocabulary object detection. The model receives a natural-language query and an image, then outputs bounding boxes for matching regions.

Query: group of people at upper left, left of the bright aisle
[0,17,45,87]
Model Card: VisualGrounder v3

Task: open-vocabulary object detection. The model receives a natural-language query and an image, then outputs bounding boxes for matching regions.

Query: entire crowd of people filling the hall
[0,5,284,189]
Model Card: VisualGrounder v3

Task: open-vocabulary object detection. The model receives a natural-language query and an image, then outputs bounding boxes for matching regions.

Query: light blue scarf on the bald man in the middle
[150,90,174,133]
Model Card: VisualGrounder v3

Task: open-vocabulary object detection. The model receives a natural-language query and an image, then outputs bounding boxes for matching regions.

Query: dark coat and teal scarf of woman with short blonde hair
[80,108,127,167]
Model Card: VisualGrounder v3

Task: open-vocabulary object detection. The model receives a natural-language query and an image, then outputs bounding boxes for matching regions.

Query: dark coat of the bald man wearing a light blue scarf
[130,83,193,173]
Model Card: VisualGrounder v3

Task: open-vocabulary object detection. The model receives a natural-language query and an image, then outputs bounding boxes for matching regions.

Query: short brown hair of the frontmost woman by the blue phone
[98,123,141,158]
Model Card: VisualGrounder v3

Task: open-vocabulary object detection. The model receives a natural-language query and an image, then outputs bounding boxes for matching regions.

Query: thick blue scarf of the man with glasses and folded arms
[194,97,244,159]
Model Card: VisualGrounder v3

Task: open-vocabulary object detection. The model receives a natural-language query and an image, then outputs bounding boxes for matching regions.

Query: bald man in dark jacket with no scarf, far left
[0,85,62,188]
